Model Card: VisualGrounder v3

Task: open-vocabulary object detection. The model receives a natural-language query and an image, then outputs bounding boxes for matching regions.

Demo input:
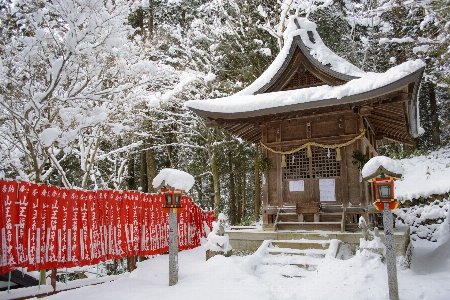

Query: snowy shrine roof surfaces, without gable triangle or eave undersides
[185,17,425,119]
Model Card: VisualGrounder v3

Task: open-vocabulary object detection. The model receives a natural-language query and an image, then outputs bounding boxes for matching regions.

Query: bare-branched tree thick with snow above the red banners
[0,0,165,187]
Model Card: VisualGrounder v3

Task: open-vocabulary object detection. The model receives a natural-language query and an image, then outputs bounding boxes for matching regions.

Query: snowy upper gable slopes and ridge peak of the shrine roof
[236,16,365,95]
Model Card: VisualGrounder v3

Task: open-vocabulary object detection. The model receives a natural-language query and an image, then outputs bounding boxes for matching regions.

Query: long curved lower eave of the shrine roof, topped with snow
[185,59,425,118]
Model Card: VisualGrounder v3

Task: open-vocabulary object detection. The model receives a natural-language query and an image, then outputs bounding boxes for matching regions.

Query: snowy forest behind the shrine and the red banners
[0,0,450,225]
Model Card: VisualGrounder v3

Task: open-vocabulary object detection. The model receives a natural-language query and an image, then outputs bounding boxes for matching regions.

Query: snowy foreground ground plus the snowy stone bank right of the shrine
[13,149,450,300]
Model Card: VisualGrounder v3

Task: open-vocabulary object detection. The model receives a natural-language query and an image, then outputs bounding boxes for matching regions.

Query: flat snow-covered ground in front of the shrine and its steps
[36,232,450,300]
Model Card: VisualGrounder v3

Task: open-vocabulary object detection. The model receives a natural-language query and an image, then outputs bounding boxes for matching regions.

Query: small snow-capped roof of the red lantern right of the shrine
[361,156,403,180]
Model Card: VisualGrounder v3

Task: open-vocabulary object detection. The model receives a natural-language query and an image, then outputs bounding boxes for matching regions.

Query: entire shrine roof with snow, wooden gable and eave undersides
[185,17,425,144]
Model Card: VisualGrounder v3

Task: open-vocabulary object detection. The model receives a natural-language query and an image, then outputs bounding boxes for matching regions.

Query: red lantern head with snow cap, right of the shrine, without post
[361,156,403,210]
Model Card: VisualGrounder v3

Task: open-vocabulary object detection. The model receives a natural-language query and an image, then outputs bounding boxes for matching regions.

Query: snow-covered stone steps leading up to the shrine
[257,239,341,277]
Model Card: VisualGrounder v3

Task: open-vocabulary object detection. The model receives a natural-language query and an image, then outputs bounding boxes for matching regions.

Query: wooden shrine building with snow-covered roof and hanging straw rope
[186,17,425,231]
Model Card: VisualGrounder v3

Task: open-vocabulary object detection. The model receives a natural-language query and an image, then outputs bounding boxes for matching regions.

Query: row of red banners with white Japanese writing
[0,180,215,274]
